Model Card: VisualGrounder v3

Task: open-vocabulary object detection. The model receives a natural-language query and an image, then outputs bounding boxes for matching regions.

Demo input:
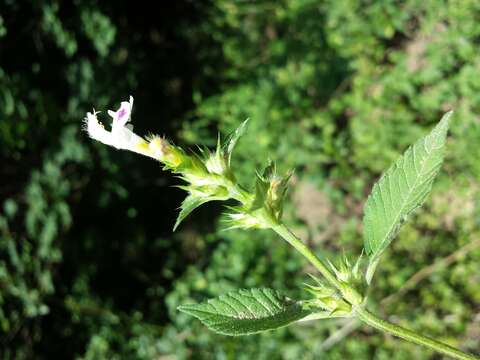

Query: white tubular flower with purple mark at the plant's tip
[85,96,150,156]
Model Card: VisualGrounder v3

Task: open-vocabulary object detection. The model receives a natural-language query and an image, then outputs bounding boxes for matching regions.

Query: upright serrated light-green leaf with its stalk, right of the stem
[363,111,452,283]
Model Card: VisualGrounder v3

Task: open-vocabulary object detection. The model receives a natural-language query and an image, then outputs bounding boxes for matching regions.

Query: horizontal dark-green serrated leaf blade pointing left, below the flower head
[178,288,311,336]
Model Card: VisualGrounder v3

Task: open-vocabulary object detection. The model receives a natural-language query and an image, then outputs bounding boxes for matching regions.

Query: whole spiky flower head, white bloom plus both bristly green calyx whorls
[85,96,290,229]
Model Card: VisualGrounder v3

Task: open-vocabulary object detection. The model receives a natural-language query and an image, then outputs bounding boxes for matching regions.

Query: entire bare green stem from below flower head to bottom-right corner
[271,223,480,360]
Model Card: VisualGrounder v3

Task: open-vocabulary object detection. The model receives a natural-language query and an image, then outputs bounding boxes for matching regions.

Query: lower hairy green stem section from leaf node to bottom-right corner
[356,308,480,360]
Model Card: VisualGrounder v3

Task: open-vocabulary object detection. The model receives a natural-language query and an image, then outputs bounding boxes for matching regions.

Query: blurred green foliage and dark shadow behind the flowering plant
[0,0,480,360]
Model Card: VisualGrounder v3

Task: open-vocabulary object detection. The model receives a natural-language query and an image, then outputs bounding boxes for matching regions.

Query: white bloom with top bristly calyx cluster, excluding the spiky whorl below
[84,96,255,228]
